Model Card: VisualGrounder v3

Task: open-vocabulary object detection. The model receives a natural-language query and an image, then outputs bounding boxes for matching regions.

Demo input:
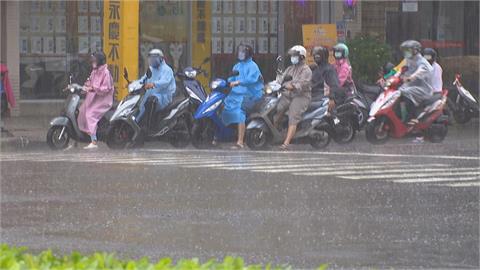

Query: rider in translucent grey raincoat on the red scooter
[399,40,433,125]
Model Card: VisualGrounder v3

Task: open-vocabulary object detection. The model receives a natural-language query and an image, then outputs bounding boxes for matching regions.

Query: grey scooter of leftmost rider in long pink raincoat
[47,75,115,150]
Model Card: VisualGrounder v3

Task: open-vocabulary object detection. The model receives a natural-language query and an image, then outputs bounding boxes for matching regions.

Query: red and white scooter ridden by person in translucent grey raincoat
[365,68,448,144]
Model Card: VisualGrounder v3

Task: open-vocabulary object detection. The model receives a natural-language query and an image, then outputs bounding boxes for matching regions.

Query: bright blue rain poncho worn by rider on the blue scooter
[222,58,263,125]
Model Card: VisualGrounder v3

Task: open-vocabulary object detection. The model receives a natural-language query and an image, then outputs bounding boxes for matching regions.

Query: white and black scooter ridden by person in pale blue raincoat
[106,69,191,149]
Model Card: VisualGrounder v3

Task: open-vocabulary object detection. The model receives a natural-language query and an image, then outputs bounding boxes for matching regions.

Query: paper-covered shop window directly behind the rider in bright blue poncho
[211,1,279,79]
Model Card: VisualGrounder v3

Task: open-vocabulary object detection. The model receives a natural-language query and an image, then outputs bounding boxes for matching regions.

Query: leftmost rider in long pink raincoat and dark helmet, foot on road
[78,52,114,149]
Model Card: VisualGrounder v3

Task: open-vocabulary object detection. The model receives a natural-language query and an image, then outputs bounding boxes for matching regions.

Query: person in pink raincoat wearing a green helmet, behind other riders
[333,43,355,96]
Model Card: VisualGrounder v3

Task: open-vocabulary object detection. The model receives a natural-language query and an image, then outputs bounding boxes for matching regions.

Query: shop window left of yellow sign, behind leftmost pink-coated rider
[20,1,103,99]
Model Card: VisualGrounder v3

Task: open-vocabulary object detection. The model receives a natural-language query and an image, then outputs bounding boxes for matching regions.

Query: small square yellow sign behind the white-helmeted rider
[302,24,337,64]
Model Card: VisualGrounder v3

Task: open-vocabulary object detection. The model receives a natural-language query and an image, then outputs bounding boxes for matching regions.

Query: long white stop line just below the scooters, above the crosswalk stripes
[144,149,480,160]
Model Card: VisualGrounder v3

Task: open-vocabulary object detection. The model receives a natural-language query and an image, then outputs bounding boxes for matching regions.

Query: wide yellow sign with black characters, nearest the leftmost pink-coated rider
[103,0,139,99]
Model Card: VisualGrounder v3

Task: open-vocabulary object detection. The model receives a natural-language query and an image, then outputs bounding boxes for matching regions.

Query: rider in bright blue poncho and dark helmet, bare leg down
[222,44,263,149]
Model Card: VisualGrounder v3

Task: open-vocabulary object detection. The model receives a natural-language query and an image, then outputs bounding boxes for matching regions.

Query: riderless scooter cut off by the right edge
[448,74,480,124]
